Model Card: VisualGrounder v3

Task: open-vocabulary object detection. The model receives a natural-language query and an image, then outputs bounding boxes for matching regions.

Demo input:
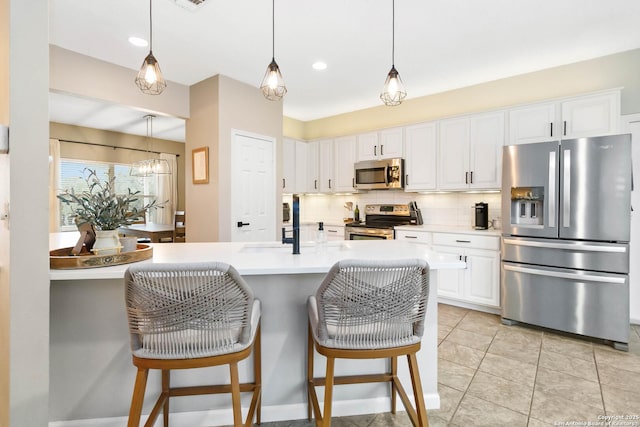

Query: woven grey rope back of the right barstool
[316,259,429,349]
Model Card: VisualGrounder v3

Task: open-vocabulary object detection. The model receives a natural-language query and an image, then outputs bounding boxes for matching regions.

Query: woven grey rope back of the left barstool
[125,263,254,359]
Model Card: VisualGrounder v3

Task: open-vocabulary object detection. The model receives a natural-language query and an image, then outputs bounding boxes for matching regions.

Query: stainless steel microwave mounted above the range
[354,158,404,190]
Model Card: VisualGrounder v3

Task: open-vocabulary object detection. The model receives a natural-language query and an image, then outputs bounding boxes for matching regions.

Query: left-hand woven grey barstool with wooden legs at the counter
[125,263,261,427]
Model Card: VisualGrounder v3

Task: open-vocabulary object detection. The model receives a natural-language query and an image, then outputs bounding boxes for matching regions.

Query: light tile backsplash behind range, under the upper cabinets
[283,191,501,227]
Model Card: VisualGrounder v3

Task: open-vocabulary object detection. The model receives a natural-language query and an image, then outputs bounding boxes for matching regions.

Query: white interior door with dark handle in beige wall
[231,130,276,242]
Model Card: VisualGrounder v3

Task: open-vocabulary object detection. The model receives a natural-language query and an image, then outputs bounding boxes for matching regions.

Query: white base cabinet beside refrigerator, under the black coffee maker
[433,233,500,308]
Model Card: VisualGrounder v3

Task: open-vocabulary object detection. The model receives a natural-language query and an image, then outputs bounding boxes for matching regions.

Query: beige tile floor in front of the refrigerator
[262,304,640,427]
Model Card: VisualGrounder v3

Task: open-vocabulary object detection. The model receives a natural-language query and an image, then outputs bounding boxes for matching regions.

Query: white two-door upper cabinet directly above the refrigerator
[508,90,620,144]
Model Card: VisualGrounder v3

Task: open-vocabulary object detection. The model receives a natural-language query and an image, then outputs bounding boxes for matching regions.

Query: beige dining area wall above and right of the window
[49,122,185,210]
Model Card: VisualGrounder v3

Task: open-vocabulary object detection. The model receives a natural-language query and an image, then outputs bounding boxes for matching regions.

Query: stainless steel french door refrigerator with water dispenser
[501,135,632,350]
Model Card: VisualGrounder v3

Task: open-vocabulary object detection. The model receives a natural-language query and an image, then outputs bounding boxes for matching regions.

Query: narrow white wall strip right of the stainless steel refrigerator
[622,113,640,325]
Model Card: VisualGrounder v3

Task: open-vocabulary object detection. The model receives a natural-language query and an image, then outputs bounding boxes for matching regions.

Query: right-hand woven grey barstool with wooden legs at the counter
[307,259,429,427]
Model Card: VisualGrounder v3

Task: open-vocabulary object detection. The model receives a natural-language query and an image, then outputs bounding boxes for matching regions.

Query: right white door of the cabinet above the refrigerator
[562,92,620,139]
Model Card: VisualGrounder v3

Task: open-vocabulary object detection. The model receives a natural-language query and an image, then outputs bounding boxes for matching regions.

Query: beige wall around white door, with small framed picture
[186,75,282,241]
